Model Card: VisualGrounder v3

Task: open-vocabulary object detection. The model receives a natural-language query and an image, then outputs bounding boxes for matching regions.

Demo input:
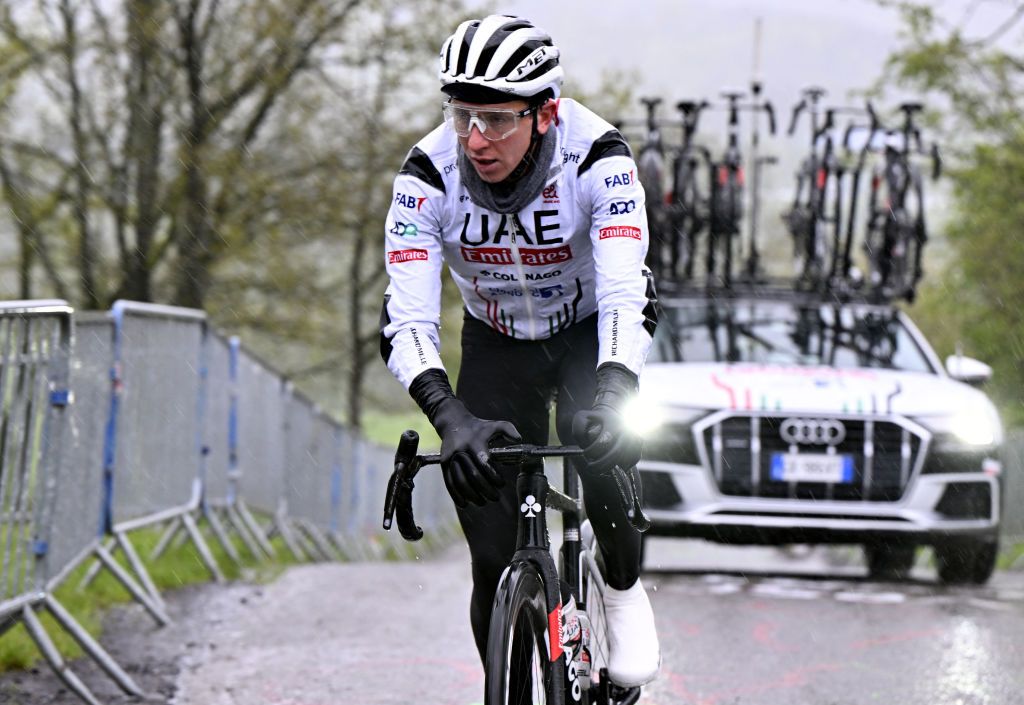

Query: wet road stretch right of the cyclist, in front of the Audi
[643,543,1024,705]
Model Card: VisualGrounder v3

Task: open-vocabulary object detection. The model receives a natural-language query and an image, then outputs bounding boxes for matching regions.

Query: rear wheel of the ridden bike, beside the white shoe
[580,520,641,705]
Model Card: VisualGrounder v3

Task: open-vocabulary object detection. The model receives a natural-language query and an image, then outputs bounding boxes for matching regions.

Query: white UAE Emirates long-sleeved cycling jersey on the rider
[381,99,656,388]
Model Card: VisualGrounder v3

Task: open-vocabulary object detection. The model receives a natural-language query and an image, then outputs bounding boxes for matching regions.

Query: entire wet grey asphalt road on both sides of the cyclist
[0,539,1024,705]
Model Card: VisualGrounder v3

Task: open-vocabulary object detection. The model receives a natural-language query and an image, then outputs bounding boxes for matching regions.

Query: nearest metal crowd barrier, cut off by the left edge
[0,300,142,705]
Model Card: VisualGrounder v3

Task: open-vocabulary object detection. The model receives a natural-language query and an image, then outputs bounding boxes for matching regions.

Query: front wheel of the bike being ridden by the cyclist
[483,563,552,705]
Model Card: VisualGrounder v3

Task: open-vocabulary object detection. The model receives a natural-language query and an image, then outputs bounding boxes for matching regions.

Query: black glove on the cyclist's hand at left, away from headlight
[409,369,522,507]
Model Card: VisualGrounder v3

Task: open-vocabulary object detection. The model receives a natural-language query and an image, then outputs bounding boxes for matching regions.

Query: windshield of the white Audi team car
[648,300,934,372]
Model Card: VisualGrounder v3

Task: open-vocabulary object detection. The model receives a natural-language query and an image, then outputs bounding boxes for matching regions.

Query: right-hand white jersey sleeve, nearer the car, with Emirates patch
[580,131,657,375]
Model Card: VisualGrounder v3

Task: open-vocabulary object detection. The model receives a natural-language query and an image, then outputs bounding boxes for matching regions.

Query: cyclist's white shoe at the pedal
[604,580,662,688]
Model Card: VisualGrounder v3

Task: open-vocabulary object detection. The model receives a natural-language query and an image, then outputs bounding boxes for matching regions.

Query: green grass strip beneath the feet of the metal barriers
[0,518,297,672]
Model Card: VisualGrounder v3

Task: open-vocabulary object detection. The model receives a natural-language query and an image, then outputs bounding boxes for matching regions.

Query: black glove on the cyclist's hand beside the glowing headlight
[572,363,643,471]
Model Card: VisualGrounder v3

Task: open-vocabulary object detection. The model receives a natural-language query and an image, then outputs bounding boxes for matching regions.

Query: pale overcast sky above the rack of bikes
[477,0,1008,122]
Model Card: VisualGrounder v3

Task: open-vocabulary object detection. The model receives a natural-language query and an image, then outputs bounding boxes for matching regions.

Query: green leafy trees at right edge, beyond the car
[880,0,1024,424]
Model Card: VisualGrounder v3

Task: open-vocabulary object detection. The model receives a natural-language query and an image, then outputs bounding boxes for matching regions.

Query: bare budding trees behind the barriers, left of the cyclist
[0,0,477,425]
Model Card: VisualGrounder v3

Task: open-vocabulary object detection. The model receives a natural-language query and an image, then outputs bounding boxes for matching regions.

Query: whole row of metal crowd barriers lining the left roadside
[0,301,457,705]
